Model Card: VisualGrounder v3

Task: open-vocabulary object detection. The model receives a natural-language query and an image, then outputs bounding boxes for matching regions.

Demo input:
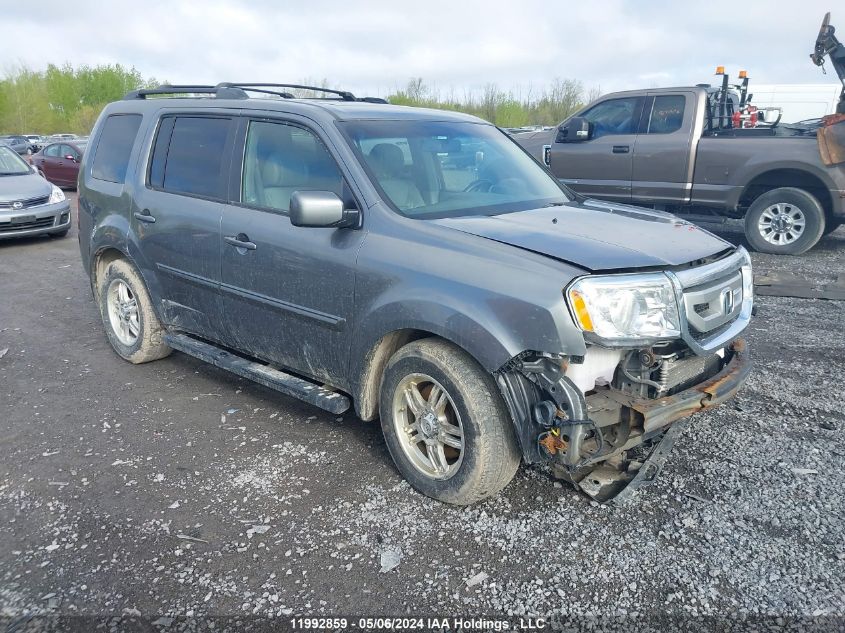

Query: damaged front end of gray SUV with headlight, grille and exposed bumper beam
[496,248,753,502]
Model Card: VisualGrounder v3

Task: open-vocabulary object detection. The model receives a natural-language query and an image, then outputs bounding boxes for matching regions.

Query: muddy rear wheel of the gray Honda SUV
[97,259,173,364]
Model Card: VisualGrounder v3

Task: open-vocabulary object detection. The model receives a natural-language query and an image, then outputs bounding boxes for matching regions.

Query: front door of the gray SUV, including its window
[221,115,364,387]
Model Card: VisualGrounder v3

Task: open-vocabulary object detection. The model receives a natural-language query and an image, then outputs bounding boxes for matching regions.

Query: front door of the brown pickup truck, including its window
[550,96,645,202]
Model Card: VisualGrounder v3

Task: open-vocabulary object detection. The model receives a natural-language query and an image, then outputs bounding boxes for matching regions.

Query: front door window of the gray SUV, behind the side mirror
[241,121,344,211]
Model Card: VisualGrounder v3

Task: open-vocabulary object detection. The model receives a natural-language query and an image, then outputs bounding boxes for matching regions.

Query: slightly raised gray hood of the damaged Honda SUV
[432,200,733,271]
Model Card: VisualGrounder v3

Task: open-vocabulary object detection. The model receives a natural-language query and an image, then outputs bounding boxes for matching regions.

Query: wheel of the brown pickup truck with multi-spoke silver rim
[745,187,825,255]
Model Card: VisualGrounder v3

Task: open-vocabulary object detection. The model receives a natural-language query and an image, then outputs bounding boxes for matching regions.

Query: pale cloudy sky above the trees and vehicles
[0,0,845,95]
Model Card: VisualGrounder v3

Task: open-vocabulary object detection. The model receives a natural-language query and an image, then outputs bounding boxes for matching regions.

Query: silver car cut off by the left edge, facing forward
[0,145,70,240]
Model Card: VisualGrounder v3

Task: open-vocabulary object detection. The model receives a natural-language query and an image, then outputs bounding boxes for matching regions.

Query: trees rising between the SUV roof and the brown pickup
[388,77,597,127]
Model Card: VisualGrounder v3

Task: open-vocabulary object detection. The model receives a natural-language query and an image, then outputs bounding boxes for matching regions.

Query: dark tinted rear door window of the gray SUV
[149,116,232,199]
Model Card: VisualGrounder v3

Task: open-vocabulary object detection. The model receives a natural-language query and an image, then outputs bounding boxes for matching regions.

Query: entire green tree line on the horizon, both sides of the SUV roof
[0,64,599,134]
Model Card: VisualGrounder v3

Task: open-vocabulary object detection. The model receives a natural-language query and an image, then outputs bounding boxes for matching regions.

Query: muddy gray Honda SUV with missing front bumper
[79,83,752,504]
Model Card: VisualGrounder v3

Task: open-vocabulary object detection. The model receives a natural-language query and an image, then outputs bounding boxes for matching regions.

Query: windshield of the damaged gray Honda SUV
[340,121,570,219]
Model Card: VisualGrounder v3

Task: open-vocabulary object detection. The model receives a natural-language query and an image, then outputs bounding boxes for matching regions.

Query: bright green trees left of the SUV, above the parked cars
[0,64,158,134]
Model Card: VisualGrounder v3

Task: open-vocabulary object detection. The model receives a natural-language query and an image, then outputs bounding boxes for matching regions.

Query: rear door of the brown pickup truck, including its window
[631,91,697,203]
